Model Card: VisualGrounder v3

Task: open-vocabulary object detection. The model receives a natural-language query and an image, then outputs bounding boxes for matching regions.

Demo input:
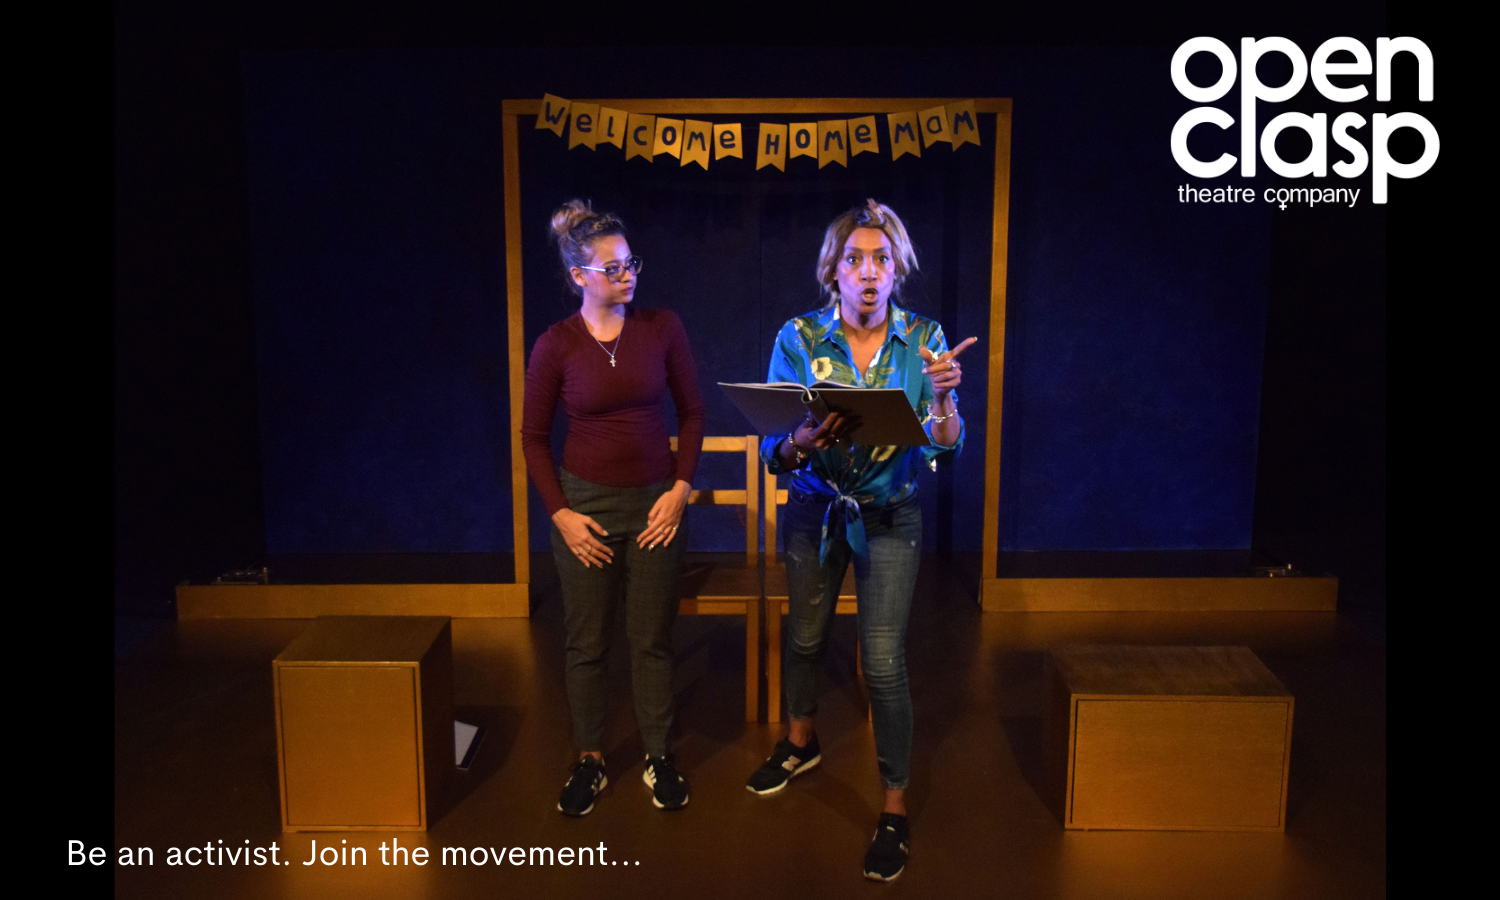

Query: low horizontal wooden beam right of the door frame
[983,576,1338,612]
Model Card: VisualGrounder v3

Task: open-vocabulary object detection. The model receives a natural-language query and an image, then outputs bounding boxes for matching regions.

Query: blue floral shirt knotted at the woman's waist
[761,303,965,554]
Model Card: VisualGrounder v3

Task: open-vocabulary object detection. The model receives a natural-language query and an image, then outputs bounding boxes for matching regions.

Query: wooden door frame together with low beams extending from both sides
[177,98,1338,618]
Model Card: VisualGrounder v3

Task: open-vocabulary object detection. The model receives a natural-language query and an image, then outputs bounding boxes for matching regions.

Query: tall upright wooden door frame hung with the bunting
[501,98,1011,612]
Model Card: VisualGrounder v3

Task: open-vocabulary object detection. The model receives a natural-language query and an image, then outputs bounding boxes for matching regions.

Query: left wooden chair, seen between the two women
[672,435,762,722]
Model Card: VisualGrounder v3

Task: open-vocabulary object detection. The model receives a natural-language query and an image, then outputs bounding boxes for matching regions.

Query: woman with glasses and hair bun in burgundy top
[521,200,704,816]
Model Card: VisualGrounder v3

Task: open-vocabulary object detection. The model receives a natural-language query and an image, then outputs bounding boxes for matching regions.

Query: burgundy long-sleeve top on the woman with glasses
[521,306,704,515]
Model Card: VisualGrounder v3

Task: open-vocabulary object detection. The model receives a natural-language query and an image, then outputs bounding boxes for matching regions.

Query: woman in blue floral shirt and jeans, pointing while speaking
[746,200,977,881]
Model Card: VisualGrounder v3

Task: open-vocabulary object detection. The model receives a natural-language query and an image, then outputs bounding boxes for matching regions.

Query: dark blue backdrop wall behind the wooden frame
[245,48,1269,554]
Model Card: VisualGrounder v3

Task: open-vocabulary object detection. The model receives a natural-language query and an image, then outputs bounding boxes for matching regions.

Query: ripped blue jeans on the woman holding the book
[782,489,923,791]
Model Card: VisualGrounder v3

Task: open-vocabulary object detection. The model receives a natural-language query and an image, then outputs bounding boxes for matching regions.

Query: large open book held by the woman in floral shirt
[719,381,929,447]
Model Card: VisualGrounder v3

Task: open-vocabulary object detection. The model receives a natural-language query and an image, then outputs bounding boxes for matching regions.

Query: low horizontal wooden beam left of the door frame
[177,584,531,620]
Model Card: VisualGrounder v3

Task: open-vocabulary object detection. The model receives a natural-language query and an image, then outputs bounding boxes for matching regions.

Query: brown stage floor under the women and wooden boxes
[114,558,1386,900]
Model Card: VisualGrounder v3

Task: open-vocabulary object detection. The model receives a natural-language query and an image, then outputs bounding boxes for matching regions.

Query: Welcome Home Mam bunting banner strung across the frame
[537,95,980,173]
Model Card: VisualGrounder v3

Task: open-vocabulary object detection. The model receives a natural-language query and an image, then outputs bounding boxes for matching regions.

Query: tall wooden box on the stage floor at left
[272,615,453,831]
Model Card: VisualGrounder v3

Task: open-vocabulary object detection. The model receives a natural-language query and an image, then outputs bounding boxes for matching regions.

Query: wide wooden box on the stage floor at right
[1043,647,1293,831]
